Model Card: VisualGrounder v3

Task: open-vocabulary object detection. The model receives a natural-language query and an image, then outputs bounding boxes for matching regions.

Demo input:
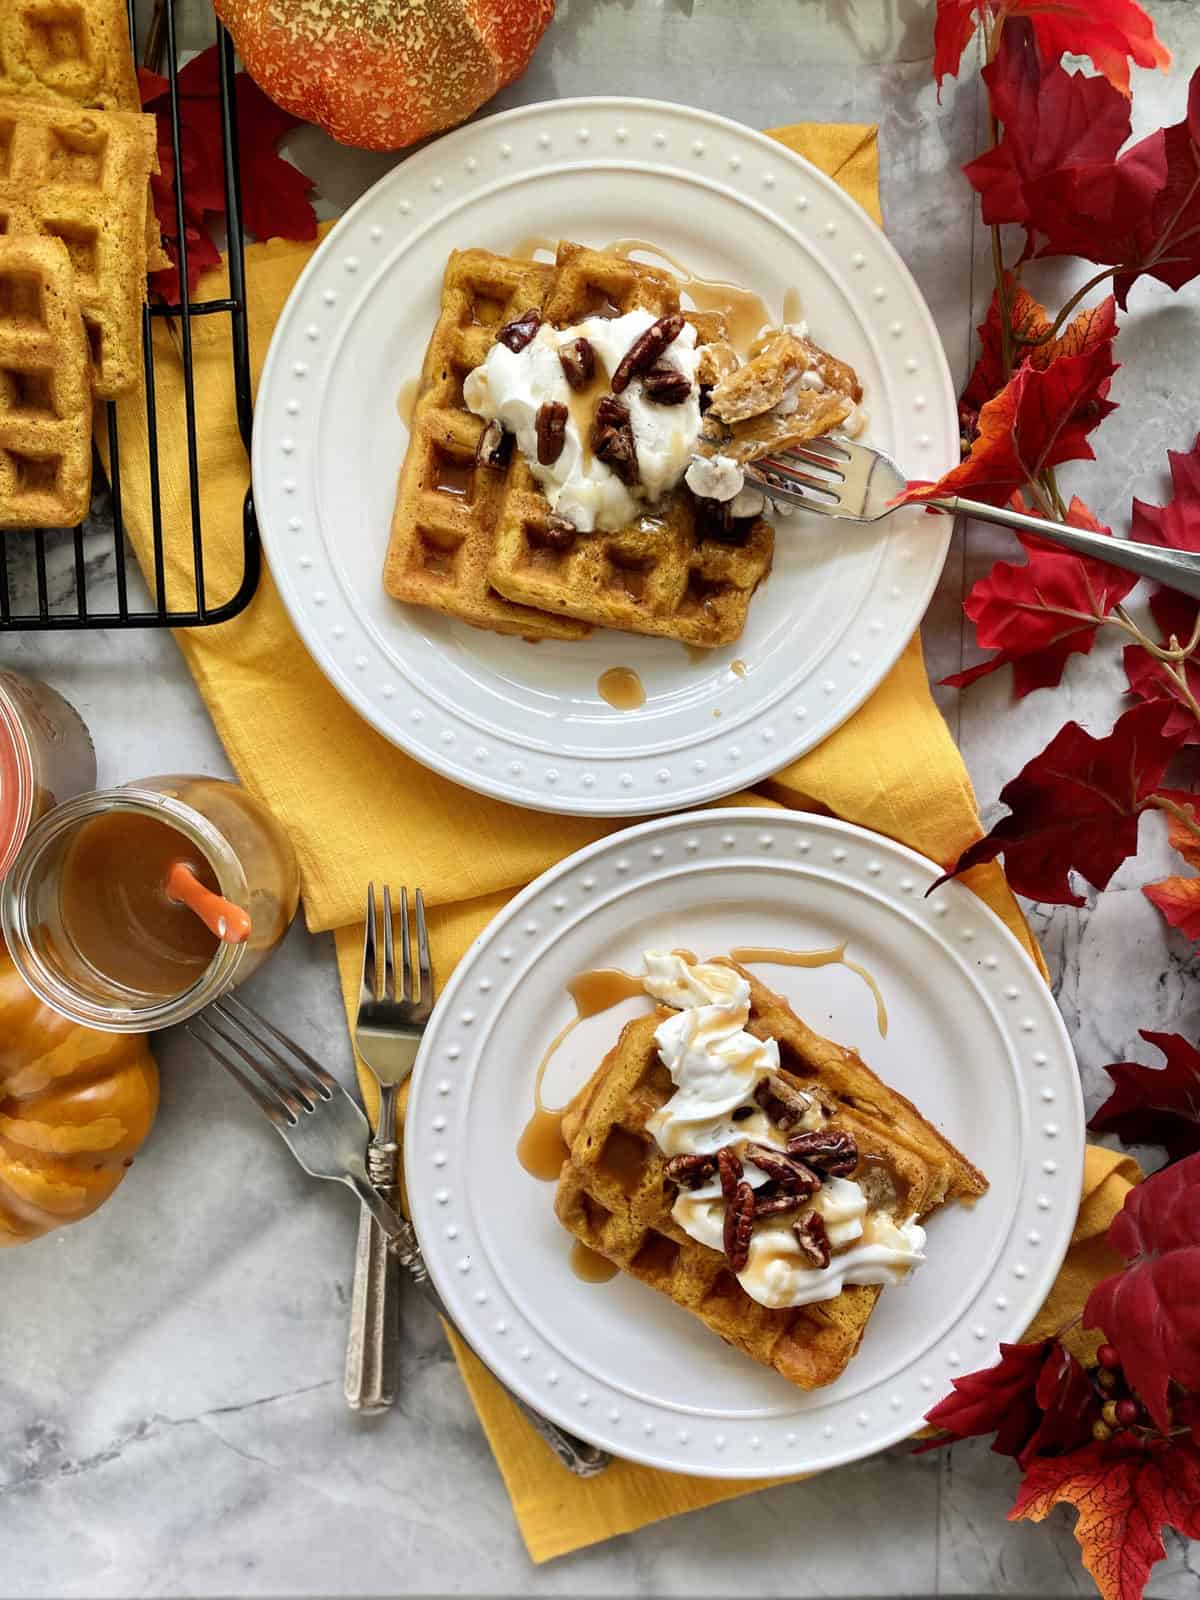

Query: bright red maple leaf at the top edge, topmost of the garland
[933,0,1171,94]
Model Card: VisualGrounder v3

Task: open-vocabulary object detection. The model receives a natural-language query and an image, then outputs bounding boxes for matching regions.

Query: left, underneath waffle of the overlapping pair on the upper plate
[384,250,587,638]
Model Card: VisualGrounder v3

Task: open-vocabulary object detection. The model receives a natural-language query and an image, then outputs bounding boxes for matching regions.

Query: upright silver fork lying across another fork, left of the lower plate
[346,883,434,1414]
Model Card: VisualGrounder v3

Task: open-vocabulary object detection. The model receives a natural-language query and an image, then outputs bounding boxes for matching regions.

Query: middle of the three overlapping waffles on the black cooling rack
[0,96,157,397]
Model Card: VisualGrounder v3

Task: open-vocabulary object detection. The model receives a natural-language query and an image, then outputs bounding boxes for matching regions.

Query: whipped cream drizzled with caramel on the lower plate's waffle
[642,950,925,1309]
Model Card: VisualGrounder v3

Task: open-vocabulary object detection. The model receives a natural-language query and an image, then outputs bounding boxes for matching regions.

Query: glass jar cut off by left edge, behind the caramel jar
[0,672,96,878]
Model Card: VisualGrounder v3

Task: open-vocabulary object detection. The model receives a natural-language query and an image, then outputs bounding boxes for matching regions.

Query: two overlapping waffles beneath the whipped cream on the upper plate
[384,243,773,646]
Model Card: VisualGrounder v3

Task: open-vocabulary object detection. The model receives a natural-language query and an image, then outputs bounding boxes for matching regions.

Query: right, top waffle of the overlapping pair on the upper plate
[485,243,774,646]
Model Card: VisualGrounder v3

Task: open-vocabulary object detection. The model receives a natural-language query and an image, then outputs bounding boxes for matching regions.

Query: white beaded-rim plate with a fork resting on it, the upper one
[253,99,958,816]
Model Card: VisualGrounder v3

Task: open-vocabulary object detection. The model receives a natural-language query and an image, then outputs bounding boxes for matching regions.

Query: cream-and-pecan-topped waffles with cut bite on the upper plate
[384,242,861,646]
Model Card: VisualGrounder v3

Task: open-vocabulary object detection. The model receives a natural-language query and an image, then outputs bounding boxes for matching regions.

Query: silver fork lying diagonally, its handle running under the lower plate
[187,995,611,1478]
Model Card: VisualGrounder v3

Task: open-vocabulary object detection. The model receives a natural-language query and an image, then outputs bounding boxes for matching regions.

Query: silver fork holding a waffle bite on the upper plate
[746,434,1200,598]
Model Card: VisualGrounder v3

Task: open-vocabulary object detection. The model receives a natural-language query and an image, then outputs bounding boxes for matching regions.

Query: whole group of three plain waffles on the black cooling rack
[0,0,165,528]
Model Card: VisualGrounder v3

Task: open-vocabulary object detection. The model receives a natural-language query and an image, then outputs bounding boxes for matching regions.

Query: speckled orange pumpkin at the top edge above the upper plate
[214,0,554,150]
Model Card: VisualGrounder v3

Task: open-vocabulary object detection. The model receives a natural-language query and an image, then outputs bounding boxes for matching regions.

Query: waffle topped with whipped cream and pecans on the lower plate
[555,950,987,1389]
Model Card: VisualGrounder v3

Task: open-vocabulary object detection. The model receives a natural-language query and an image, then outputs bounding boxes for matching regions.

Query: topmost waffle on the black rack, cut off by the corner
[0,0,141,110]
